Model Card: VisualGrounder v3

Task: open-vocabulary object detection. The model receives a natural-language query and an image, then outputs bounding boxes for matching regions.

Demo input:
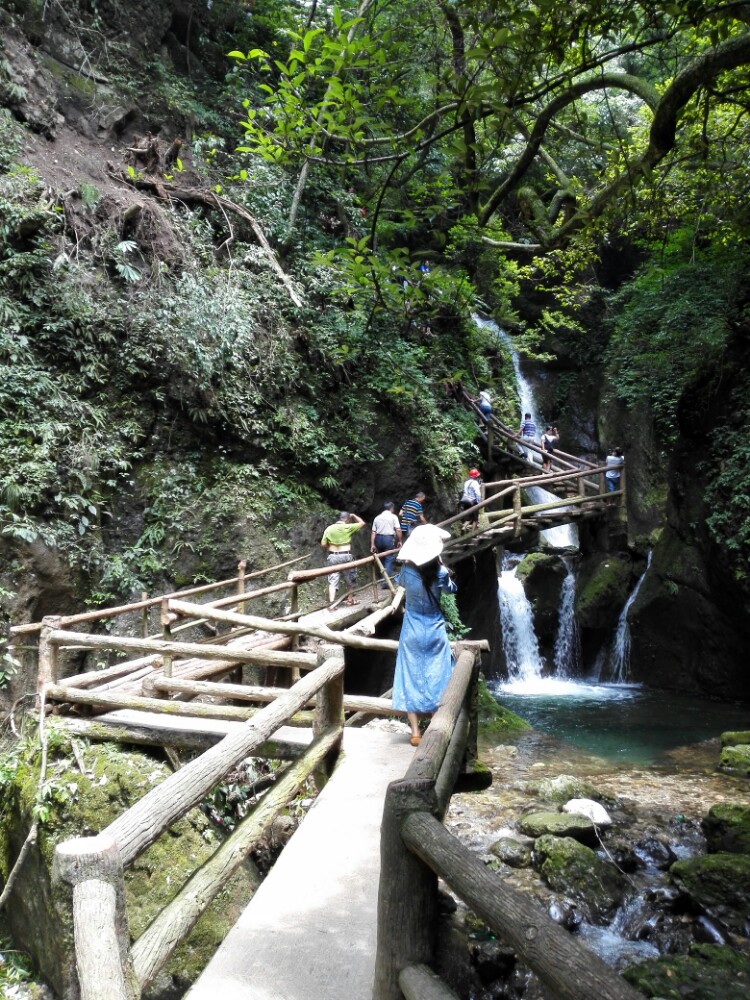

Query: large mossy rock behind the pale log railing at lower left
[0,729,257,997]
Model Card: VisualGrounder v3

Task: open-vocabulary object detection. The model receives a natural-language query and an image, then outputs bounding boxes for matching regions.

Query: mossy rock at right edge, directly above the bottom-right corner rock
[669,854,750,934]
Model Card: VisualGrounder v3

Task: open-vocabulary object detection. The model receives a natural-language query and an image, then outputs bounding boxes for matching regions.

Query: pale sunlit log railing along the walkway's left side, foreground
[53,650,344,1000]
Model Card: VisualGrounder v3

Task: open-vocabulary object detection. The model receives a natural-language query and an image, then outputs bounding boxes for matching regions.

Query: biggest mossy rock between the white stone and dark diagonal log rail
[534,835,626,924]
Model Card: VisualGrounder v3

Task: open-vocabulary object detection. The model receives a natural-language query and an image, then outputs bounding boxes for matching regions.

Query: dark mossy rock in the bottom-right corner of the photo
[622,944,750,1000]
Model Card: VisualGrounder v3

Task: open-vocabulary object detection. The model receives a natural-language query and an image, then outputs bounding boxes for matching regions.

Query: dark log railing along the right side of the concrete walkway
[373,653,642,1000]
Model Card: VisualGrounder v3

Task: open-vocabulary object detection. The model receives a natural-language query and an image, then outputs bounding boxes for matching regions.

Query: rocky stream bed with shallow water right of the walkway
[447,731,750,1000]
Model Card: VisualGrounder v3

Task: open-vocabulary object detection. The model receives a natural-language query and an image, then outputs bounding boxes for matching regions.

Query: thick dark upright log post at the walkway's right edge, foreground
[372,778,444,1000]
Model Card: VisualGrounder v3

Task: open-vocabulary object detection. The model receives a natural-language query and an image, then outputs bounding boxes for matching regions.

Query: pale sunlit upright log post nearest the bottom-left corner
[52,834,141,1000]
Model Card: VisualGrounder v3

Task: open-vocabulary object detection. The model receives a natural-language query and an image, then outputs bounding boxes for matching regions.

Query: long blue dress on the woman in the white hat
[393,563,456,713]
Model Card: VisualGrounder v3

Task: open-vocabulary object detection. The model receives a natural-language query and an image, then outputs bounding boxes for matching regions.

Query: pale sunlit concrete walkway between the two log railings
[185,728,414,1000]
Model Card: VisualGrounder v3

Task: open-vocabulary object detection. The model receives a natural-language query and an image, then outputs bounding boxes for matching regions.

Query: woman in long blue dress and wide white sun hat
[393,524,456,746]
